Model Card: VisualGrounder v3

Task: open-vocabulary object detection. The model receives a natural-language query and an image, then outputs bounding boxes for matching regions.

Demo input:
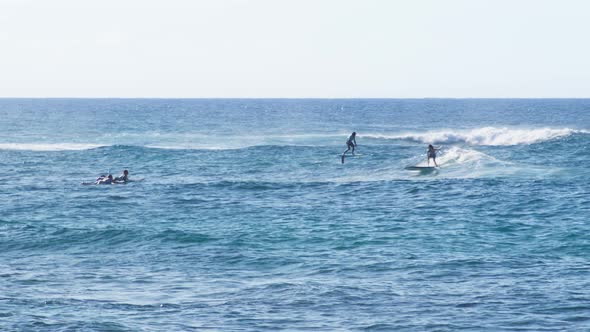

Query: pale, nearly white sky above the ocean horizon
[0,0,590,98]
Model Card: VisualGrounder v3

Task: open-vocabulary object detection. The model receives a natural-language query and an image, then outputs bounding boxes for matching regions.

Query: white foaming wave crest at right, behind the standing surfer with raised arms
[364,127,589,146]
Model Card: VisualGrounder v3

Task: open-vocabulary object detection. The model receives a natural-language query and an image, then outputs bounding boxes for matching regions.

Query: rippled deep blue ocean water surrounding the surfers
[0,99,590,331]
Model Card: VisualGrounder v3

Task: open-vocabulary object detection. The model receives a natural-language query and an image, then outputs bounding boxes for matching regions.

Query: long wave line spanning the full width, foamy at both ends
[0,127,589,151]
